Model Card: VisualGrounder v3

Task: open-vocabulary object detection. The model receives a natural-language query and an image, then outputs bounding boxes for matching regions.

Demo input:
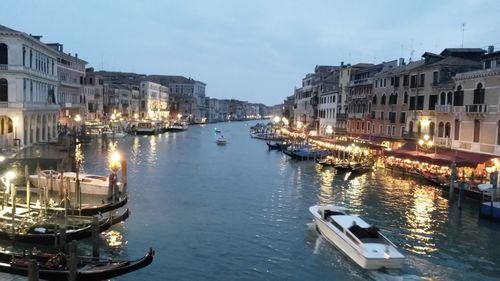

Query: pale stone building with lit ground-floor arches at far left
[0,25,59,148]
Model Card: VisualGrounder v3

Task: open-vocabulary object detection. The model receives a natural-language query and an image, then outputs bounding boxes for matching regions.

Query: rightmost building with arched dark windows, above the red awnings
[446,47,500,155]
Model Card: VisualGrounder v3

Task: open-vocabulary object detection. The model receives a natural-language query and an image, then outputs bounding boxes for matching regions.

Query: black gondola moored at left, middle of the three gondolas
[0,209,130,245]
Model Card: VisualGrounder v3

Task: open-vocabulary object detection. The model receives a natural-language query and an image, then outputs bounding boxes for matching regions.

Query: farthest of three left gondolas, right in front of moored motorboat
[10,195,128,216]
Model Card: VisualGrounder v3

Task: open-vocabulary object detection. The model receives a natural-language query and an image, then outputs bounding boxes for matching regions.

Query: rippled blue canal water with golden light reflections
[76,122,500,281]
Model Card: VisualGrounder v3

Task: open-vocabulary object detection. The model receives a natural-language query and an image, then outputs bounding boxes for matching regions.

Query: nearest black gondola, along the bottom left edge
[0,248,155,281]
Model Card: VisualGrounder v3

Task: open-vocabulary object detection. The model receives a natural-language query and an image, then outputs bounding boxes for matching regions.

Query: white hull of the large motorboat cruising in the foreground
[310,207,404,270]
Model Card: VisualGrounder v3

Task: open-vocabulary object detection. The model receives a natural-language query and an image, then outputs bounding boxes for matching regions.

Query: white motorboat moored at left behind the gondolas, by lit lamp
[29,170,123,195]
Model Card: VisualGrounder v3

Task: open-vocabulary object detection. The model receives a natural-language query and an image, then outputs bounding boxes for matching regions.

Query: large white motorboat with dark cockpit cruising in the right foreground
[309,205,404,269]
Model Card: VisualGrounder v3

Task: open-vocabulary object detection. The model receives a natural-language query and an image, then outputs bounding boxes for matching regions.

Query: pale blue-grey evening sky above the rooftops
[0,0,500,105]
